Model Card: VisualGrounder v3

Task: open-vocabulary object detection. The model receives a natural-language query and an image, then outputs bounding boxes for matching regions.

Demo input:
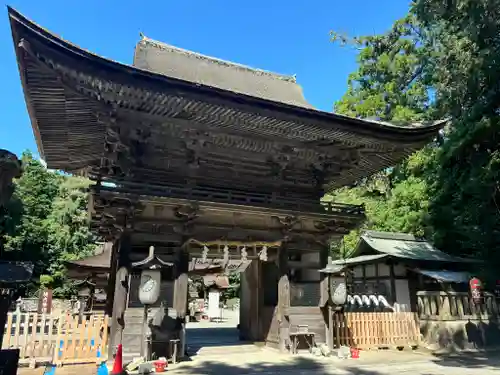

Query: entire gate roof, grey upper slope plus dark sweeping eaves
[9,8,444,179]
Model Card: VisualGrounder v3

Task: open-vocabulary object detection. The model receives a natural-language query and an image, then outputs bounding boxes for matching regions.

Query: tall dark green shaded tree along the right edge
[412,0,500,274]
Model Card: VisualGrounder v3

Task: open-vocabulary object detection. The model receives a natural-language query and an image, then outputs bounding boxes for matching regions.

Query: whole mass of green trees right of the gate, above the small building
[331,0,500,280]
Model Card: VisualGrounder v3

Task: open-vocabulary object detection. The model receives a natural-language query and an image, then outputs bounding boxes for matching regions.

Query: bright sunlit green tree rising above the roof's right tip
[332,14,431,125]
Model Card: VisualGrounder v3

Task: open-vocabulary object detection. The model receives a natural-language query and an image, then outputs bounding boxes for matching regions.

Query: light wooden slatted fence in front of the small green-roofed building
[332,312,420,349]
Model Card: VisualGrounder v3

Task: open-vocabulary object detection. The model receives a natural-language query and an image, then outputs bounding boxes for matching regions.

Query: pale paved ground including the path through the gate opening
[18,311,500,375]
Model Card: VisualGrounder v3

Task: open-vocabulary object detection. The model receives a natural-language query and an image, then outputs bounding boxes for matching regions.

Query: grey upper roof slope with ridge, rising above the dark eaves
[134,36,312,108]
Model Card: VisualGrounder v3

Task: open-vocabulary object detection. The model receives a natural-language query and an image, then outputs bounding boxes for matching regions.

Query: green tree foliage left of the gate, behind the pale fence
[0,152,95,296]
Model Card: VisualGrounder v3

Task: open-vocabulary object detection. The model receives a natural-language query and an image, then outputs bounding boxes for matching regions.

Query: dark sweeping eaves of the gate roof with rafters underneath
[9,8,443,191]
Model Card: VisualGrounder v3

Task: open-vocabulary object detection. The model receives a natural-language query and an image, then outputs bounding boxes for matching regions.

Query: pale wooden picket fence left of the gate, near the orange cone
[2,313,108,366]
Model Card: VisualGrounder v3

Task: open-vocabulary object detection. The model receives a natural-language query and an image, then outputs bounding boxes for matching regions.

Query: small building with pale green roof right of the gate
[333,231,474,312]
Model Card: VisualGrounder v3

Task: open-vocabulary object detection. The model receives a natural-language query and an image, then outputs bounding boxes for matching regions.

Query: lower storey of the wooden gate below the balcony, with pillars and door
[93,192,363,356]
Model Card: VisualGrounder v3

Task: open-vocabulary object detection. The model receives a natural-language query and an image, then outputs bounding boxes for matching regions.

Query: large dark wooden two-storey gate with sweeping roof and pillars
[9,8,443,358]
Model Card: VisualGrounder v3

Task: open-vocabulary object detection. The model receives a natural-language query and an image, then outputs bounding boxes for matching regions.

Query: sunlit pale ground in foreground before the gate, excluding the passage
[169,349,500,375]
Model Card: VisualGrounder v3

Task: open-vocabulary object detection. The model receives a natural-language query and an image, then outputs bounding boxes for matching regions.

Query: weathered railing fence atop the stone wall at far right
[417,291,500,320]
